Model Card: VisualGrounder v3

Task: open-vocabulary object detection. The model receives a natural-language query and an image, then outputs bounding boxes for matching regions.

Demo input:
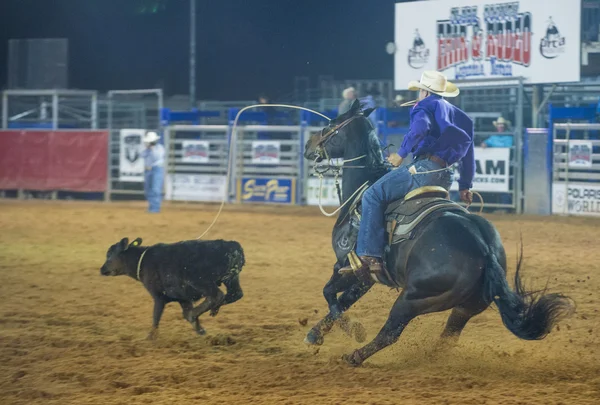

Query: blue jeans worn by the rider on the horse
[356,160,452,258]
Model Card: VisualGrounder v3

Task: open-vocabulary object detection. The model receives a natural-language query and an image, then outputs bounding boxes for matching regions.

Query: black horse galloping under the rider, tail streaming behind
[304,102,572,366]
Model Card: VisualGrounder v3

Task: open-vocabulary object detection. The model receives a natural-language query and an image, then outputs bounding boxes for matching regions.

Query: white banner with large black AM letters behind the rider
[450,147,510,192]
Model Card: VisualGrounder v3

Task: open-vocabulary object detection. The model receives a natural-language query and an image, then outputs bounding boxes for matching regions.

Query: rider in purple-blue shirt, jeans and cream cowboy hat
[340,71,475,273]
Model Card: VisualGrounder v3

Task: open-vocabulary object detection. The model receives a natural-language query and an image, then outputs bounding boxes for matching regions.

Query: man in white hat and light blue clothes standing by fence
[142,132,165,213]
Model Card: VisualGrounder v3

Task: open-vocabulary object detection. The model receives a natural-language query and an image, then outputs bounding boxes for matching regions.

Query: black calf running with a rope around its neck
[100,238,245,339]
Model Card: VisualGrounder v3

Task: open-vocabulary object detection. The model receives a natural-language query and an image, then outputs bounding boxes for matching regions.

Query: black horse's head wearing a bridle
[304,100,374,162]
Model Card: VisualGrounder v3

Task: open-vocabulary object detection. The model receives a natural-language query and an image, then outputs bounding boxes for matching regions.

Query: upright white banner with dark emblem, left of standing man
[119,129,146,182]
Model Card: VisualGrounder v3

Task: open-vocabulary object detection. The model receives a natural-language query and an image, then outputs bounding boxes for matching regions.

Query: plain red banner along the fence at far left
[0,130,108,192]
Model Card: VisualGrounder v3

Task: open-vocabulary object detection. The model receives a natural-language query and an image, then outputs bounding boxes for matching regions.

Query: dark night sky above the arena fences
[0,0,412,100]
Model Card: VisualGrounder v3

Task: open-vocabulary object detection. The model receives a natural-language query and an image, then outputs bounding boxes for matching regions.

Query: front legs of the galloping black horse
[304,263,371,345]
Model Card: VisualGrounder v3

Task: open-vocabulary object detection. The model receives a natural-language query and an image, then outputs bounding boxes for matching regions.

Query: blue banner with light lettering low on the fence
[237,177,296,204]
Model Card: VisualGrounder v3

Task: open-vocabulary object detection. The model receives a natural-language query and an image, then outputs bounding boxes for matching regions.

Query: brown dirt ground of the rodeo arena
[0,201,600,405]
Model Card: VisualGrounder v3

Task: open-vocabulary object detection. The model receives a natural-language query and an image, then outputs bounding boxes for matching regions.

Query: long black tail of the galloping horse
[468,217,573,340]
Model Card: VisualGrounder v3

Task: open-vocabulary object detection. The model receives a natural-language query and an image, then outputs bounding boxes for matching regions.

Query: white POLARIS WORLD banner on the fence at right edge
[552,182,600,217]
